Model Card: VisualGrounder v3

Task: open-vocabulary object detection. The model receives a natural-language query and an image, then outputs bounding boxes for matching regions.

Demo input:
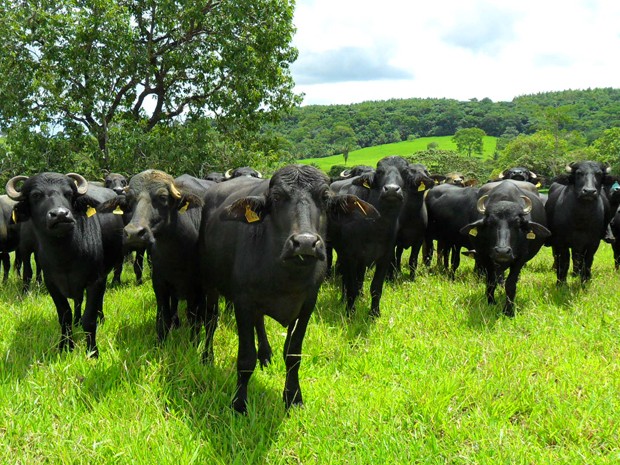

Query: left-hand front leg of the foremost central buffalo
[232,302,256,413]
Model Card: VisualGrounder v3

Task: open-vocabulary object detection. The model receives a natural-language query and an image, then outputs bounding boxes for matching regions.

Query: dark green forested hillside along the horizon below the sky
[273,88,620,158]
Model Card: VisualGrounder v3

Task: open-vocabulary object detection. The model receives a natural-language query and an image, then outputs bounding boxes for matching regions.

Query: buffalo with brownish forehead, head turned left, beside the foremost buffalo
[100,170,206,341]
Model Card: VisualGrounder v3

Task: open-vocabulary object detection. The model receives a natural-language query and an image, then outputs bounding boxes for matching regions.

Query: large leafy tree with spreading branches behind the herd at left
[0,0,299,168]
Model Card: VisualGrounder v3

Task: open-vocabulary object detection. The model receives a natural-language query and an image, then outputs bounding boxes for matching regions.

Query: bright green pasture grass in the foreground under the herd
[0,244,620,465]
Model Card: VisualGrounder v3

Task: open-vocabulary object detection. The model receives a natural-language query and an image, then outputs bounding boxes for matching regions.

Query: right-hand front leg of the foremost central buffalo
[282,297,316,409]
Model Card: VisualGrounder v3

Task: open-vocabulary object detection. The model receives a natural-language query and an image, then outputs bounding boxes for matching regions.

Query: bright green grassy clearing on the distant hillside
[299,136,497,171]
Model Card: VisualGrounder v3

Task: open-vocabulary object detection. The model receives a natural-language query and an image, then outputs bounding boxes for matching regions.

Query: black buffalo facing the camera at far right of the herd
[545,161,613,284]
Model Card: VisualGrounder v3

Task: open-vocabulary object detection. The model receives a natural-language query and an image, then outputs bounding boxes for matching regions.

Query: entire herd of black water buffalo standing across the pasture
[0,156,620,412]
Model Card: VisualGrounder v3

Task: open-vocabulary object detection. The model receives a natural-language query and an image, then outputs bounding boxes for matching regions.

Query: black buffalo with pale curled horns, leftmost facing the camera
[6,173,122,357]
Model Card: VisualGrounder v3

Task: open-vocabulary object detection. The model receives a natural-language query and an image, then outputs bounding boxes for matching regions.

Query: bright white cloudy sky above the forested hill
[292,0,620,105]
